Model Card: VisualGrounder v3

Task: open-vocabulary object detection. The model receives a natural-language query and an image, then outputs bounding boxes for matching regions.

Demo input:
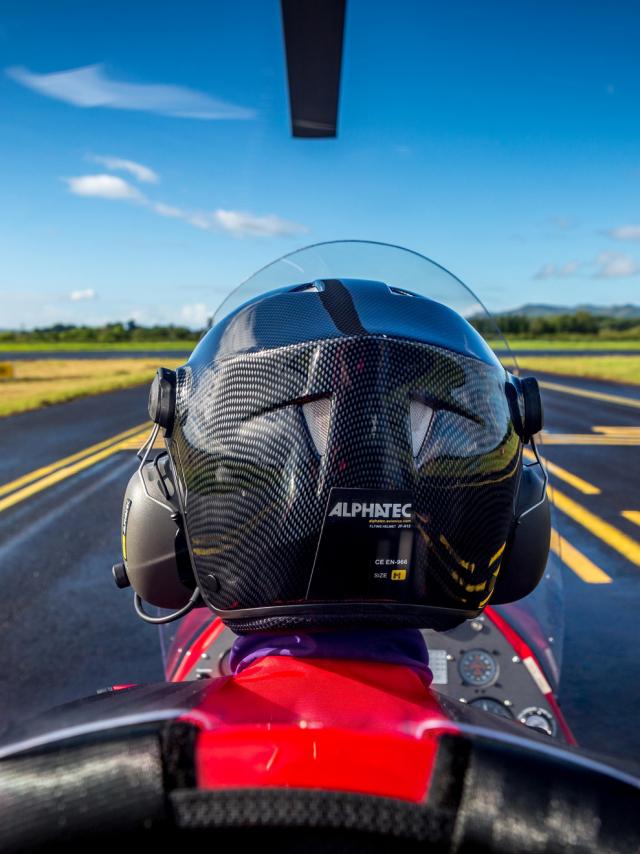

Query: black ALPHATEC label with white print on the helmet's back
[307,489,414,601]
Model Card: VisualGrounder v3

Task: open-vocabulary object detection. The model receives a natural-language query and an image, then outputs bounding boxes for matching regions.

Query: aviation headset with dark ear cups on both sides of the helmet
[113,368,551,623]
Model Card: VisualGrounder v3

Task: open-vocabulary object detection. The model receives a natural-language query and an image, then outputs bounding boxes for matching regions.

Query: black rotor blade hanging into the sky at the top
[281,0,346,137]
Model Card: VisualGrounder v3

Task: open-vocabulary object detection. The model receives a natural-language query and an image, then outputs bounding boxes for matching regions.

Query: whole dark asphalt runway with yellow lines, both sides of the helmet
[0,375,640,759]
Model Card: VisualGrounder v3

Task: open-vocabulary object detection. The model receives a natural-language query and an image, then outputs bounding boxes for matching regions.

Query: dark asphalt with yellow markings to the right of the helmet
[524,373,640,760]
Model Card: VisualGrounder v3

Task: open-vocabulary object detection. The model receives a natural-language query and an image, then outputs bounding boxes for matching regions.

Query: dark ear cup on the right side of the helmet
[491,465,551,605]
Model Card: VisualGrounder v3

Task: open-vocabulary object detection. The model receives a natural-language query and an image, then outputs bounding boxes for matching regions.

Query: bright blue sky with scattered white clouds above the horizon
[0,0,640,327]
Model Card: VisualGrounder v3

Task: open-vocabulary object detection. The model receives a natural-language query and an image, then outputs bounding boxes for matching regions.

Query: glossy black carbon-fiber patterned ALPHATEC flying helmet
[117,244,550,632]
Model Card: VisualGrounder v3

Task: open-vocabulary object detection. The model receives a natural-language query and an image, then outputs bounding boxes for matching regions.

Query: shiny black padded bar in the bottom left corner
[0,730,167,854]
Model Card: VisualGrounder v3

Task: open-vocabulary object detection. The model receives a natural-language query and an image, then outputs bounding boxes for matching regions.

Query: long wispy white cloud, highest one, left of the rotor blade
[6,65,255,120]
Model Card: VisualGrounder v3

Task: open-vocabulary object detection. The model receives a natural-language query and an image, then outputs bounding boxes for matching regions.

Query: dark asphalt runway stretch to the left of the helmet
[0,388,163,736]
